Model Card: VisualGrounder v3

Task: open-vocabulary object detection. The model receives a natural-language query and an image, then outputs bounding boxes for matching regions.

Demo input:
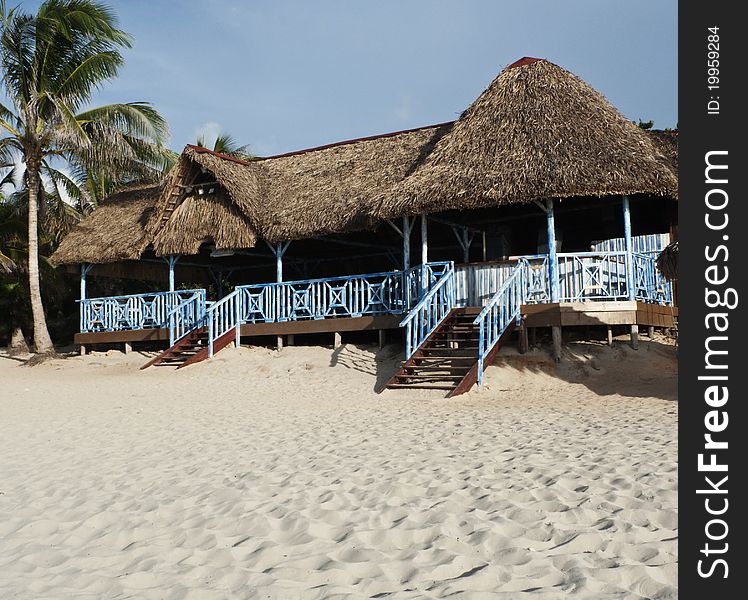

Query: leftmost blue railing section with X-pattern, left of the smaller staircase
[78,290,205,333]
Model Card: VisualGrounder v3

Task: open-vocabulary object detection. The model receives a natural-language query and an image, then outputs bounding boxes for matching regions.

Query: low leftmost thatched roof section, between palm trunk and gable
[50,184,161,265]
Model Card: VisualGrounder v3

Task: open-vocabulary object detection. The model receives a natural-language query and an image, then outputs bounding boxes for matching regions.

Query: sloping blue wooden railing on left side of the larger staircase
[400,262,456,360]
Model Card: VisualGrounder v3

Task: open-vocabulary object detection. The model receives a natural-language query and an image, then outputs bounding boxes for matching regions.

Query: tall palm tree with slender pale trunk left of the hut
[0,0,168,352]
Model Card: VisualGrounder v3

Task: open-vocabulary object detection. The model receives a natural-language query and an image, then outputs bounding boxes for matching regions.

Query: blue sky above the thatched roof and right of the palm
[20,0,677,155]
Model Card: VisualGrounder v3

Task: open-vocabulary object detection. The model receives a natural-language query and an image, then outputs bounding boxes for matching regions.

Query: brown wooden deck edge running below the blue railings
[74,301,678,346]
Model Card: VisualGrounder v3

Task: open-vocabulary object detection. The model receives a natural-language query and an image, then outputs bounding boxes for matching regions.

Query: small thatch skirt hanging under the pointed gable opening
[153,191,257,256]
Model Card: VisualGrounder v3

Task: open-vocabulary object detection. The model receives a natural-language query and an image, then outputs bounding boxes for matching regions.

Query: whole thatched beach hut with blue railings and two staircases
[53,58,677,393]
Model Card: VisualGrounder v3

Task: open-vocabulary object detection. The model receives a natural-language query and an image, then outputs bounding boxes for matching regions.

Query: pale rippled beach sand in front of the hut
[0,339,678,600]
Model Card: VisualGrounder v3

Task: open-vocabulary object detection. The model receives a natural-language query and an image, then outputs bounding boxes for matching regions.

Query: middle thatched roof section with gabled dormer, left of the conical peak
[149,123,452,255]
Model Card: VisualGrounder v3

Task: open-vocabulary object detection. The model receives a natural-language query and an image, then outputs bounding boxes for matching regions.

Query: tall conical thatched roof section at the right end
[374,58,677,218]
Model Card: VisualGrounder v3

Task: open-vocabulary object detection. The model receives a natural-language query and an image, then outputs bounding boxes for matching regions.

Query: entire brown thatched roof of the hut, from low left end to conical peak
[55,59,677,262]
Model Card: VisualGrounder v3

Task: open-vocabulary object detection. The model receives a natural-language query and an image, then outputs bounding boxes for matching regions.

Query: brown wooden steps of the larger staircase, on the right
[380,308,514,398]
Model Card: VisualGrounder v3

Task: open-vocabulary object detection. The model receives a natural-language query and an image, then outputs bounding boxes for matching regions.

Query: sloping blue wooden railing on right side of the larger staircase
[473,260,529,385]
